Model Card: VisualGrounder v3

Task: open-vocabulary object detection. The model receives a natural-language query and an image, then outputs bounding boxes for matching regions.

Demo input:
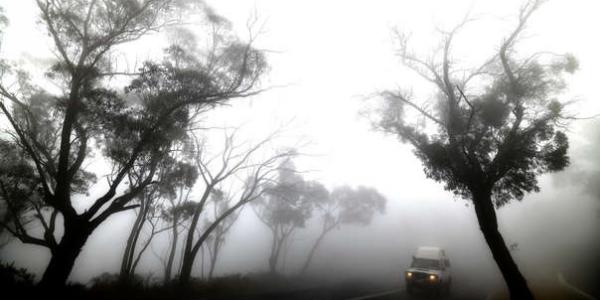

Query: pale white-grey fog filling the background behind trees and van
[0,0,600,297]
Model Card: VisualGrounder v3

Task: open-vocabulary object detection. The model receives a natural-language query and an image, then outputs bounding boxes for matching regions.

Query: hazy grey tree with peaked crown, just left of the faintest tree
[253,159,329,273]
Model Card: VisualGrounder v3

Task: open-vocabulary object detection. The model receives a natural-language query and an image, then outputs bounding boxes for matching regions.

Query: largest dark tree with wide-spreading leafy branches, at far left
[0,0,266,287]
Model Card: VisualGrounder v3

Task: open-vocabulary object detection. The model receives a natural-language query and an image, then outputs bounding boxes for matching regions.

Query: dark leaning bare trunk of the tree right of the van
[473,191,533,300]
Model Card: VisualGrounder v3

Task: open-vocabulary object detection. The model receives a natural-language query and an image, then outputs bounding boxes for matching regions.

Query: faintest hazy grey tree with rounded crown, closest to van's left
[300,186,387,274]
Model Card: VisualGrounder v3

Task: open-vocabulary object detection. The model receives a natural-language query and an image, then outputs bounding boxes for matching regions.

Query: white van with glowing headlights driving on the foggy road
[404,247,452,295]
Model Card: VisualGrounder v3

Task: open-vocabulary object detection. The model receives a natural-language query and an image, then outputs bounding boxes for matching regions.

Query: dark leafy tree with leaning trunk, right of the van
[378,0,577,299]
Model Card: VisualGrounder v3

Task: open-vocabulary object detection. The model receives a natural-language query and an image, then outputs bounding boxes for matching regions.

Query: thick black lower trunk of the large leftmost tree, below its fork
[39,220,92,289]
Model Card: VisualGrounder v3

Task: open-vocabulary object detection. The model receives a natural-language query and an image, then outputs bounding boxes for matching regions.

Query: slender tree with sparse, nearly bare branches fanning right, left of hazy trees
[179,130,295,285]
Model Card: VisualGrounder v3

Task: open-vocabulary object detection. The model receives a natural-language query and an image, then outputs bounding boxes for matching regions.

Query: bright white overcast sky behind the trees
[0,0,600,292]
